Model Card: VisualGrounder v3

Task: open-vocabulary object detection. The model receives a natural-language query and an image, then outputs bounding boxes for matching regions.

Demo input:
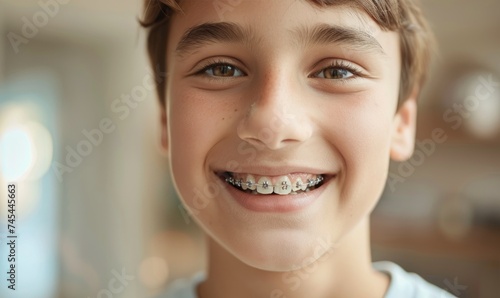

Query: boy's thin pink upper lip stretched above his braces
[214,164,335,176]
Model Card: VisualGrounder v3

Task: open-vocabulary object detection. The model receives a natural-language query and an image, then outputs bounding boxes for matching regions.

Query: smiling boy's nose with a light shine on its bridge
[237,70,312,150]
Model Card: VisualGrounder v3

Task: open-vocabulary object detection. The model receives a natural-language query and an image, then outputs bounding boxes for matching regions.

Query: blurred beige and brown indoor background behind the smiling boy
[0,0,500,298]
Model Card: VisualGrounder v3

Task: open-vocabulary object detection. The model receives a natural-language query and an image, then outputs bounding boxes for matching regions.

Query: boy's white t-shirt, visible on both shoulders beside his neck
[158,262,456,298]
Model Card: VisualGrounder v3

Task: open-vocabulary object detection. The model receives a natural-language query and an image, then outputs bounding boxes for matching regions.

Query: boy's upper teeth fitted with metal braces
[226,174,324,195]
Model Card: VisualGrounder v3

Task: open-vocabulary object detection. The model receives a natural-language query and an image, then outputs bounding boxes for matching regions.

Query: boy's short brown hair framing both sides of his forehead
[141,0,434,105]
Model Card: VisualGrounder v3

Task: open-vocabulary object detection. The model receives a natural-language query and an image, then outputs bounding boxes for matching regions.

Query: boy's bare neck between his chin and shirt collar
[198,220,389,298]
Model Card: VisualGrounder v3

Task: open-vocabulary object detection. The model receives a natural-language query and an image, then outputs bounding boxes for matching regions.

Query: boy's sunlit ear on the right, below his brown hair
[390,91,418,161]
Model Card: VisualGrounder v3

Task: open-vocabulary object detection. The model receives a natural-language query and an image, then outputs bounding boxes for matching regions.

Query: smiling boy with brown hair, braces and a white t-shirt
[144,0,452,298]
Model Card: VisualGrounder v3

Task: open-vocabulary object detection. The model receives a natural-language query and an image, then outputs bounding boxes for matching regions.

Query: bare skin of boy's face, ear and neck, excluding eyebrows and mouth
[161,0,417,298]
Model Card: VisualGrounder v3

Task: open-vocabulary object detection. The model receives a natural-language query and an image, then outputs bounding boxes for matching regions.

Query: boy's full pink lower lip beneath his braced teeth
[220,177,334,213]
